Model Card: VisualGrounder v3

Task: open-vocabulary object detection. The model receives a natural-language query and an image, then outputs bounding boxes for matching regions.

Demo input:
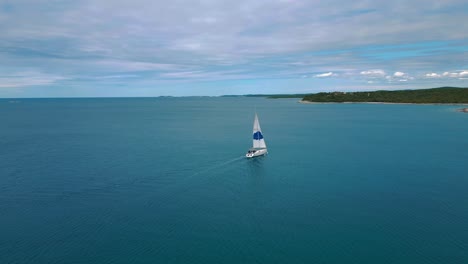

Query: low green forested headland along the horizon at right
[302,87,468,104]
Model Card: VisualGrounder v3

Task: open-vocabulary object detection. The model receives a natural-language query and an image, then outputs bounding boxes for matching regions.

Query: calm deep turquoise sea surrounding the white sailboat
[0,98,468,264]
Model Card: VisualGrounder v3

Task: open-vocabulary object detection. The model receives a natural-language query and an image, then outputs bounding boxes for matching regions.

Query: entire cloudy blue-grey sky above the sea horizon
[0,0,468,97]
